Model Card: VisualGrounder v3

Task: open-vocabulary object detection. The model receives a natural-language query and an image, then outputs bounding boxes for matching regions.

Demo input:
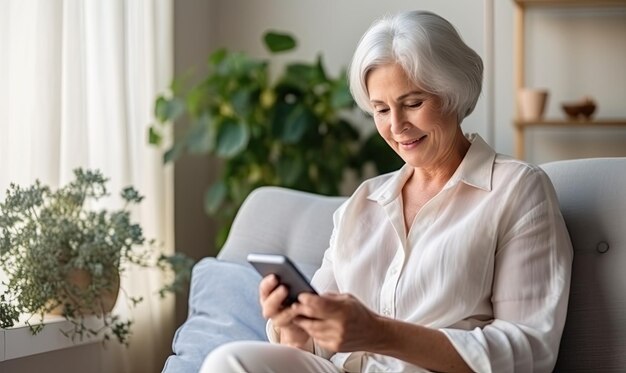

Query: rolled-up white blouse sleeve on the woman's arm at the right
[442,168,573,372]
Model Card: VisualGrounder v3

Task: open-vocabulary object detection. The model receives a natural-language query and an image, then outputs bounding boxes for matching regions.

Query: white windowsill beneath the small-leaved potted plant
[0,316,102,361]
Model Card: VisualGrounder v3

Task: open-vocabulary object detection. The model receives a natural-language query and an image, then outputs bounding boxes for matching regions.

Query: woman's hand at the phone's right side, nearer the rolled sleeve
[292,293,380,352]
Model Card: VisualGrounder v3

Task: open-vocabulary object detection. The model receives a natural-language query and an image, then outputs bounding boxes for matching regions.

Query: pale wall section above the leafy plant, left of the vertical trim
[210,0,487,144]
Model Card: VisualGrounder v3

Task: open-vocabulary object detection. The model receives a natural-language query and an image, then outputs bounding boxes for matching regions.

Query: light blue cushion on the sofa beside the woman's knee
[163,258,266,373]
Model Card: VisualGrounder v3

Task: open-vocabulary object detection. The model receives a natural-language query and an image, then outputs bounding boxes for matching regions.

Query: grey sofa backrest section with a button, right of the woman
[541,158,626,372]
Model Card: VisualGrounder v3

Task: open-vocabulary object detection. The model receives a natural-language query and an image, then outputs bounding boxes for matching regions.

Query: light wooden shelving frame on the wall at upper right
[513,0,626,159]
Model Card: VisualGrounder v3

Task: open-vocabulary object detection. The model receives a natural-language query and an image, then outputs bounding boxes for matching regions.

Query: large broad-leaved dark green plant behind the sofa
[149,31,399,247]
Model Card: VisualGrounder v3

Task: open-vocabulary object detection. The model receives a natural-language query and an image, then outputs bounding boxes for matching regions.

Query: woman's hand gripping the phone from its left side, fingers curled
[259,275,310,350]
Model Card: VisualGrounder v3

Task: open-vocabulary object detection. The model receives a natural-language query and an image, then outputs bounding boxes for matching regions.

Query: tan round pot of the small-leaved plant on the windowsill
[47,269,120,315]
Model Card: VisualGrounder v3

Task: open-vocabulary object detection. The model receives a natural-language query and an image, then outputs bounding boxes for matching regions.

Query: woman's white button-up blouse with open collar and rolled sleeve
[304,135,572,372]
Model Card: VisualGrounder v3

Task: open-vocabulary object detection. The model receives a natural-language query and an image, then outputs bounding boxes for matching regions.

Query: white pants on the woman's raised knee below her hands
[200,341,342,373]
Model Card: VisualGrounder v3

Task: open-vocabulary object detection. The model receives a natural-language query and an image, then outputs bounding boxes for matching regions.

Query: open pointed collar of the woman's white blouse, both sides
[367,134,496,205]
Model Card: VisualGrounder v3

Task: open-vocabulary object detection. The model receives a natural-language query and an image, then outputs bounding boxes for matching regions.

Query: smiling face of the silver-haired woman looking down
[366,64,460,168]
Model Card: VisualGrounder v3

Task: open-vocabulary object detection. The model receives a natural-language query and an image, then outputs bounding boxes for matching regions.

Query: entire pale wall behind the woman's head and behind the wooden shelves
[201,0,626,163]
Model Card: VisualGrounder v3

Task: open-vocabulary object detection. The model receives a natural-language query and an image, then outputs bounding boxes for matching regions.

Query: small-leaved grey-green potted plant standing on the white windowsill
[0,169,192,344]
